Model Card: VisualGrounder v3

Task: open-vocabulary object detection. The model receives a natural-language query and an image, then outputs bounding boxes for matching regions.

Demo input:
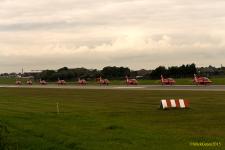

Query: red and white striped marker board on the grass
[160,99,190,109]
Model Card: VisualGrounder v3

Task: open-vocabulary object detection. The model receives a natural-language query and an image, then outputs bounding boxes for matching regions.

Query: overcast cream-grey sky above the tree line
[0,0,225,72]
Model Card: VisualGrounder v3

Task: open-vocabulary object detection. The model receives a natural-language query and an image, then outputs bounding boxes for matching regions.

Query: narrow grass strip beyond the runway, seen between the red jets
[0,77,225,85]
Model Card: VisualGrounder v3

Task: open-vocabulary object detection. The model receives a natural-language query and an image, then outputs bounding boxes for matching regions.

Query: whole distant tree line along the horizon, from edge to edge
[0,63,222,81]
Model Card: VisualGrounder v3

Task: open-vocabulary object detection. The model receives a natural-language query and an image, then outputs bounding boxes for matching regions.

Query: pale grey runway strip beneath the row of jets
[0,84,225,91]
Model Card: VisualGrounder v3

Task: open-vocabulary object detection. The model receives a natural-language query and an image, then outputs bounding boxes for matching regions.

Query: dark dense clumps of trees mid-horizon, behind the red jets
[35,64,200,81]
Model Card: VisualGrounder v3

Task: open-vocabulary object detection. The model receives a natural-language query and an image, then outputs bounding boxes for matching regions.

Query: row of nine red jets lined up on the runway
[16,74,212,85]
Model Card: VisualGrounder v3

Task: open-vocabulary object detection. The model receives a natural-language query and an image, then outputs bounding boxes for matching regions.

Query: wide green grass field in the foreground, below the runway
[0,88,225,150]
